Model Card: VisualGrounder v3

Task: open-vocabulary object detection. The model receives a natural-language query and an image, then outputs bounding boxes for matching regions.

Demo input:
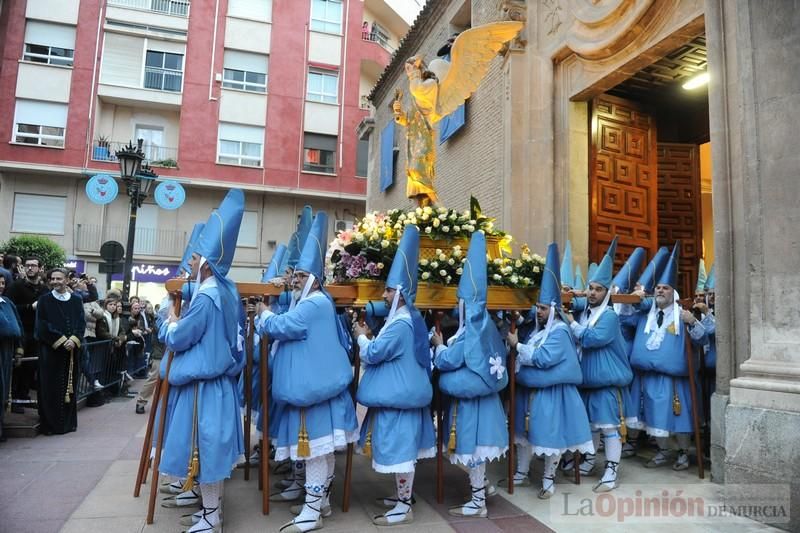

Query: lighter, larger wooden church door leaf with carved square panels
[589,95,658,268]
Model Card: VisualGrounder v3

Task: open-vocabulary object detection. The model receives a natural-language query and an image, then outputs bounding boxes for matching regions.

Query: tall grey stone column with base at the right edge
[706,0,800,531]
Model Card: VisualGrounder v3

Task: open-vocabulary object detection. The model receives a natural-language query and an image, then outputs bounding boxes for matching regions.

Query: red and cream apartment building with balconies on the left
[0,0,421,280]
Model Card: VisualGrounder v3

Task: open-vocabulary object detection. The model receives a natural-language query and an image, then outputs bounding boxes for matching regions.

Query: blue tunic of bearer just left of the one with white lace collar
[571,306,633,429]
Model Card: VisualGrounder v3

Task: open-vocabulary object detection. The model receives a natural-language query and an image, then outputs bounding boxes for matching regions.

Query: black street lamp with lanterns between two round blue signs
[116,139,158,315]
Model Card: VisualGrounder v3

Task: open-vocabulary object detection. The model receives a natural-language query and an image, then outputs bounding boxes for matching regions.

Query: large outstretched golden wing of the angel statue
[437,21,523,117]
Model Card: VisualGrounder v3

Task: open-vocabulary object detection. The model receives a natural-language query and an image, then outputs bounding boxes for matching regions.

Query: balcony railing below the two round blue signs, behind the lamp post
[75,224,186,258]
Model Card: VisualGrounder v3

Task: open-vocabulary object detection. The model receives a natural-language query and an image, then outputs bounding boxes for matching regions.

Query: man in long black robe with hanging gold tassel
[36,268,86,435]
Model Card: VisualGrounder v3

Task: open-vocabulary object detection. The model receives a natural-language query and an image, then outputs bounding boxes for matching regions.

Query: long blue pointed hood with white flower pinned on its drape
[453,231,508,391]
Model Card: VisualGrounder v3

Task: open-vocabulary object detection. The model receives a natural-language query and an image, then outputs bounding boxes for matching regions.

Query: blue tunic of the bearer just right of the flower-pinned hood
[515,321,594,455]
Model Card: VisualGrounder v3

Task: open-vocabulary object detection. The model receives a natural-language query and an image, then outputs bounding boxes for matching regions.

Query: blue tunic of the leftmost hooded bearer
[160,277,244,483]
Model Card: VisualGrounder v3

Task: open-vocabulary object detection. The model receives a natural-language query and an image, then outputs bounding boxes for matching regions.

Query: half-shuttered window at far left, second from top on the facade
[14,100,67,148]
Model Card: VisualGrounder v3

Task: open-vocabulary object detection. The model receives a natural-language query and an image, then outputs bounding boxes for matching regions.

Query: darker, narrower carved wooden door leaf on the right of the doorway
[658,143,703,298]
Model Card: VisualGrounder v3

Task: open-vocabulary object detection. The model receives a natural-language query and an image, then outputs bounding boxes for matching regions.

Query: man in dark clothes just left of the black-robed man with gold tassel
[6,257,47,413]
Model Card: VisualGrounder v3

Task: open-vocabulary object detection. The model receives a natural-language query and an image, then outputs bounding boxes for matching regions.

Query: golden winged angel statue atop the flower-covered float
[392,21,523,206]
